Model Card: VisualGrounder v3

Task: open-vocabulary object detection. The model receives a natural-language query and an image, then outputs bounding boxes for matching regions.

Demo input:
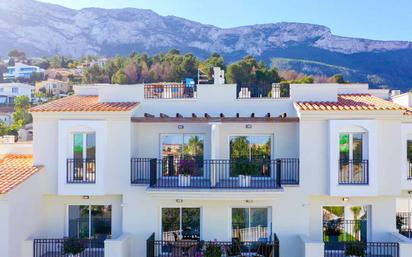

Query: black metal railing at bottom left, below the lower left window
[33,239,104,257]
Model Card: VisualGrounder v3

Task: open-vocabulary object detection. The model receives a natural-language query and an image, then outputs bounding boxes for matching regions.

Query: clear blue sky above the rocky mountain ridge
[41,0,412,41]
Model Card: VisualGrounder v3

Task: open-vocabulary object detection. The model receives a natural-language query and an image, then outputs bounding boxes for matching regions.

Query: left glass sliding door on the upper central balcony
[161,134,204,176]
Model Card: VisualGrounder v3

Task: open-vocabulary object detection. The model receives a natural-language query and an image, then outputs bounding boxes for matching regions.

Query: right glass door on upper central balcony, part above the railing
[230,135,272,160]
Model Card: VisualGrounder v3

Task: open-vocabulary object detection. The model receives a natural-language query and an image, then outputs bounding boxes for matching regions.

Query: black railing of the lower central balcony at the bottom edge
[146,233,280,257]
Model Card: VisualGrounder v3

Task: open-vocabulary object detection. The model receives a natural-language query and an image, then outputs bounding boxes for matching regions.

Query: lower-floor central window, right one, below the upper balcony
[232,208,271,242]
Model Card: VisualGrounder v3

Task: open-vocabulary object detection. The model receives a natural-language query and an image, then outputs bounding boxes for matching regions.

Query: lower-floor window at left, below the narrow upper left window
[68,205,112,240]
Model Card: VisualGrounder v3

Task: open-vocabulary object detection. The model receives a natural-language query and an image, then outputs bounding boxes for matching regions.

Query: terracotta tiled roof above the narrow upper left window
[30,95,139,112]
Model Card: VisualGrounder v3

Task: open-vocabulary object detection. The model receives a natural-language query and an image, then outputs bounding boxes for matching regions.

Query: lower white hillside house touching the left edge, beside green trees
[0,83,35,102]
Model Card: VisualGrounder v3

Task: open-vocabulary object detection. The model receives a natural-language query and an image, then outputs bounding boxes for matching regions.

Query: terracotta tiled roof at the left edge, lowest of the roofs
[0,154,41,194]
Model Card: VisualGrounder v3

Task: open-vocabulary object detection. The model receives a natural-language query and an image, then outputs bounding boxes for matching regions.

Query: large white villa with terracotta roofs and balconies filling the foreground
[0,68,412,257]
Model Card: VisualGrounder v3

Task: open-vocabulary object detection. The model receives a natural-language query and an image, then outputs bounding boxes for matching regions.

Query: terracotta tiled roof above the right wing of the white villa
[295,94,406,111]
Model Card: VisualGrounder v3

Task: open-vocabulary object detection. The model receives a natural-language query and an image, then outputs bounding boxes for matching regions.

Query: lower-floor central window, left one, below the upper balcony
[162,208,200,241]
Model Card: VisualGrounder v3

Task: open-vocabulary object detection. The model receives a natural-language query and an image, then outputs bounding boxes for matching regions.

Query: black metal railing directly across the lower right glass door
[323,219,367,243]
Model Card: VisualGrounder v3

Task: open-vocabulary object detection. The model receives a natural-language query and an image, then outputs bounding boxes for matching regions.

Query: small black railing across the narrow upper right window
[339,159,369,185]
